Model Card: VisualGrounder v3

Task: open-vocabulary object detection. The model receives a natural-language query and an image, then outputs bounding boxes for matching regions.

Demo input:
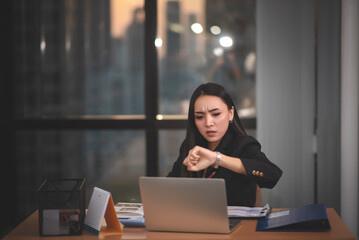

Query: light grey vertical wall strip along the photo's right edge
[341,0,359,238]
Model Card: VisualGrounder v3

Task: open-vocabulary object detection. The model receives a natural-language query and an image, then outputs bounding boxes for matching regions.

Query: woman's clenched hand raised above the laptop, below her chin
[187,146,217,171]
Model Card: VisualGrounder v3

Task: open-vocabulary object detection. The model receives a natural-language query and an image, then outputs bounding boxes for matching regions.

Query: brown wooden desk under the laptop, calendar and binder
[3,208,355,240]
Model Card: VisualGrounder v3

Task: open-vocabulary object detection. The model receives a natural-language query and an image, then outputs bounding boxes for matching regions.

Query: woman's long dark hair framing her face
[183,82,247,165]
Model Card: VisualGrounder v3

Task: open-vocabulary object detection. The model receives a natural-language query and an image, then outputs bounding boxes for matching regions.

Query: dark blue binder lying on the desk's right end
[257,204,330,232]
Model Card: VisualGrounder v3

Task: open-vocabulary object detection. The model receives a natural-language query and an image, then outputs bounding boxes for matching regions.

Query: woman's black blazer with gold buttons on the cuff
[168,128,282,206]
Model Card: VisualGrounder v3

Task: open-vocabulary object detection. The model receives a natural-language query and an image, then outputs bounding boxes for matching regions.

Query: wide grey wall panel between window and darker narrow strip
[257,0,315,207]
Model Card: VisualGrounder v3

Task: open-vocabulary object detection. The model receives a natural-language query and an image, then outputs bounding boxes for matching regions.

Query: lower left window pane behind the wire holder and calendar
[16,130,146,218]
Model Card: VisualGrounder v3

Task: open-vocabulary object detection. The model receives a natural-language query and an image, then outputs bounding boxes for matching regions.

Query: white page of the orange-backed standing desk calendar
[85,187,111,231]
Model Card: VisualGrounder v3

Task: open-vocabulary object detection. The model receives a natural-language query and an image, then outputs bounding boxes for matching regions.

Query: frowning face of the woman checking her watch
[194,95,234,150]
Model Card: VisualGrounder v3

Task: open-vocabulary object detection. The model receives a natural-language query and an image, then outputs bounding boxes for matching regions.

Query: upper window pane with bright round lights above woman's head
[155,0,256,117]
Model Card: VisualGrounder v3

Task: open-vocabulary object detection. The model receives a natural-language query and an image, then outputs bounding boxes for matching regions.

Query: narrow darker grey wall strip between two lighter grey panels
[316,0,341,213]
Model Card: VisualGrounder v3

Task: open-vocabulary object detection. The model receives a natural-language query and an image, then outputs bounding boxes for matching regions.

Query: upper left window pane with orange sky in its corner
[13,0,145,118]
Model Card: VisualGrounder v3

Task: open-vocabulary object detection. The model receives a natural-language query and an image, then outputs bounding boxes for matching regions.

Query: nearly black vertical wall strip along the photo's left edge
[0,1,16,238]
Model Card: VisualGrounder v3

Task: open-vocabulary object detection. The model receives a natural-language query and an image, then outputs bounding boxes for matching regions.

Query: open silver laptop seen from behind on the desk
[139,177,240,233]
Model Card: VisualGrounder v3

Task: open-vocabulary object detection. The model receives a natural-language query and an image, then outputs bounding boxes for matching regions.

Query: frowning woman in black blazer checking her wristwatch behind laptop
[168,83,282,206]
